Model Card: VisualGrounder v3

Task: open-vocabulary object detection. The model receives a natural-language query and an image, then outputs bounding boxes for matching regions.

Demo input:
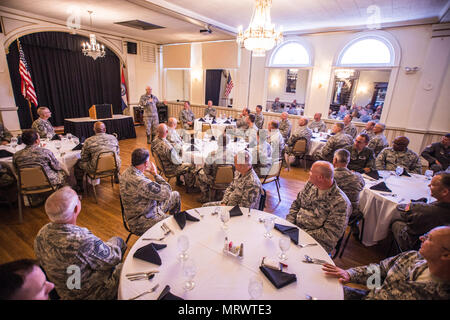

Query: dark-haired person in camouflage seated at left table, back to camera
[13,129,68,187]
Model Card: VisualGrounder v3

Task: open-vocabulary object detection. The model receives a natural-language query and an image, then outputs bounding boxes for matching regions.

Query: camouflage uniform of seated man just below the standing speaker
[152,137,195,188]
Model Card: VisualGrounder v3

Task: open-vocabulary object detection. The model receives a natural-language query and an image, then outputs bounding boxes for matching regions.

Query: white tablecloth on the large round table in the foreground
[118,207,343,300]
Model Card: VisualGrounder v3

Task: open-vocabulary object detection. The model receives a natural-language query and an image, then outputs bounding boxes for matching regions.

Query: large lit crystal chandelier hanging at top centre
[236,0,283,57]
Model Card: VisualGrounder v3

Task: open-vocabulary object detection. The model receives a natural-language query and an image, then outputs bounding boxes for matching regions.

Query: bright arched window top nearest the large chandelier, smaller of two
[270,41,311,67]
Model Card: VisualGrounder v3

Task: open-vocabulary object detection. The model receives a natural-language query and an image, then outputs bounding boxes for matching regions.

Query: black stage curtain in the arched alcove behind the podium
[7,32,122,129]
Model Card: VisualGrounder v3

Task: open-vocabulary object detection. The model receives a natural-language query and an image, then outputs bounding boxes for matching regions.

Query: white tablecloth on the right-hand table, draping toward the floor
[359,172,436,246]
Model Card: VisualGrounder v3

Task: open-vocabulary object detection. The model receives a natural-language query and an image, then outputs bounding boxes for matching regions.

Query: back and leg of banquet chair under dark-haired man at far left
[16,164,56,223]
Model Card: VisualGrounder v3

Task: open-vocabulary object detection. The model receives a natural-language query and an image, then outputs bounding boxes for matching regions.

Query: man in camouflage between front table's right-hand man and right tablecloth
[333,149,366,220]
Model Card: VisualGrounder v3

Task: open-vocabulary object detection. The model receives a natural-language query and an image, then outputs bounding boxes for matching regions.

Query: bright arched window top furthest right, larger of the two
[337,36,395,66]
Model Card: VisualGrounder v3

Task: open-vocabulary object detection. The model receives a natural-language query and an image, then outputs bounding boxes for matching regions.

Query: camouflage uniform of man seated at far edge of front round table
[203,169,262,209]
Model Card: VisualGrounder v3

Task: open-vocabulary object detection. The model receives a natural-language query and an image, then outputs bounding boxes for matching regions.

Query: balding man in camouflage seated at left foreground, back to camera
[34,187,127,300]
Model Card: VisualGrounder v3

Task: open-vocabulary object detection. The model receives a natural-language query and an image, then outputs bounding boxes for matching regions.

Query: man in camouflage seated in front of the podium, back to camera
[74,121,121,192]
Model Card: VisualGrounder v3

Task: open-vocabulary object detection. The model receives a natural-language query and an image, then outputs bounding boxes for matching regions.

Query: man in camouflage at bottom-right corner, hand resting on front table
[322,226,450,300]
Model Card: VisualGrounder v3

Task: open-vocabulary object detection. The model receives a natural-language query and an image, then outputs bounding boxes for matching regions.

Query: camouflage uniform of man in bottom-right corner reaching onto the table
[344,251,450,300]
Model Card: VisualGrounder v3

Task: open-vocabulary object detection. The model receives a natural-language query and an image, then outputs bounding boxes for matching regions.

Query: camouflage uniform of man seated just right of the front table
[286,182,351,253]
